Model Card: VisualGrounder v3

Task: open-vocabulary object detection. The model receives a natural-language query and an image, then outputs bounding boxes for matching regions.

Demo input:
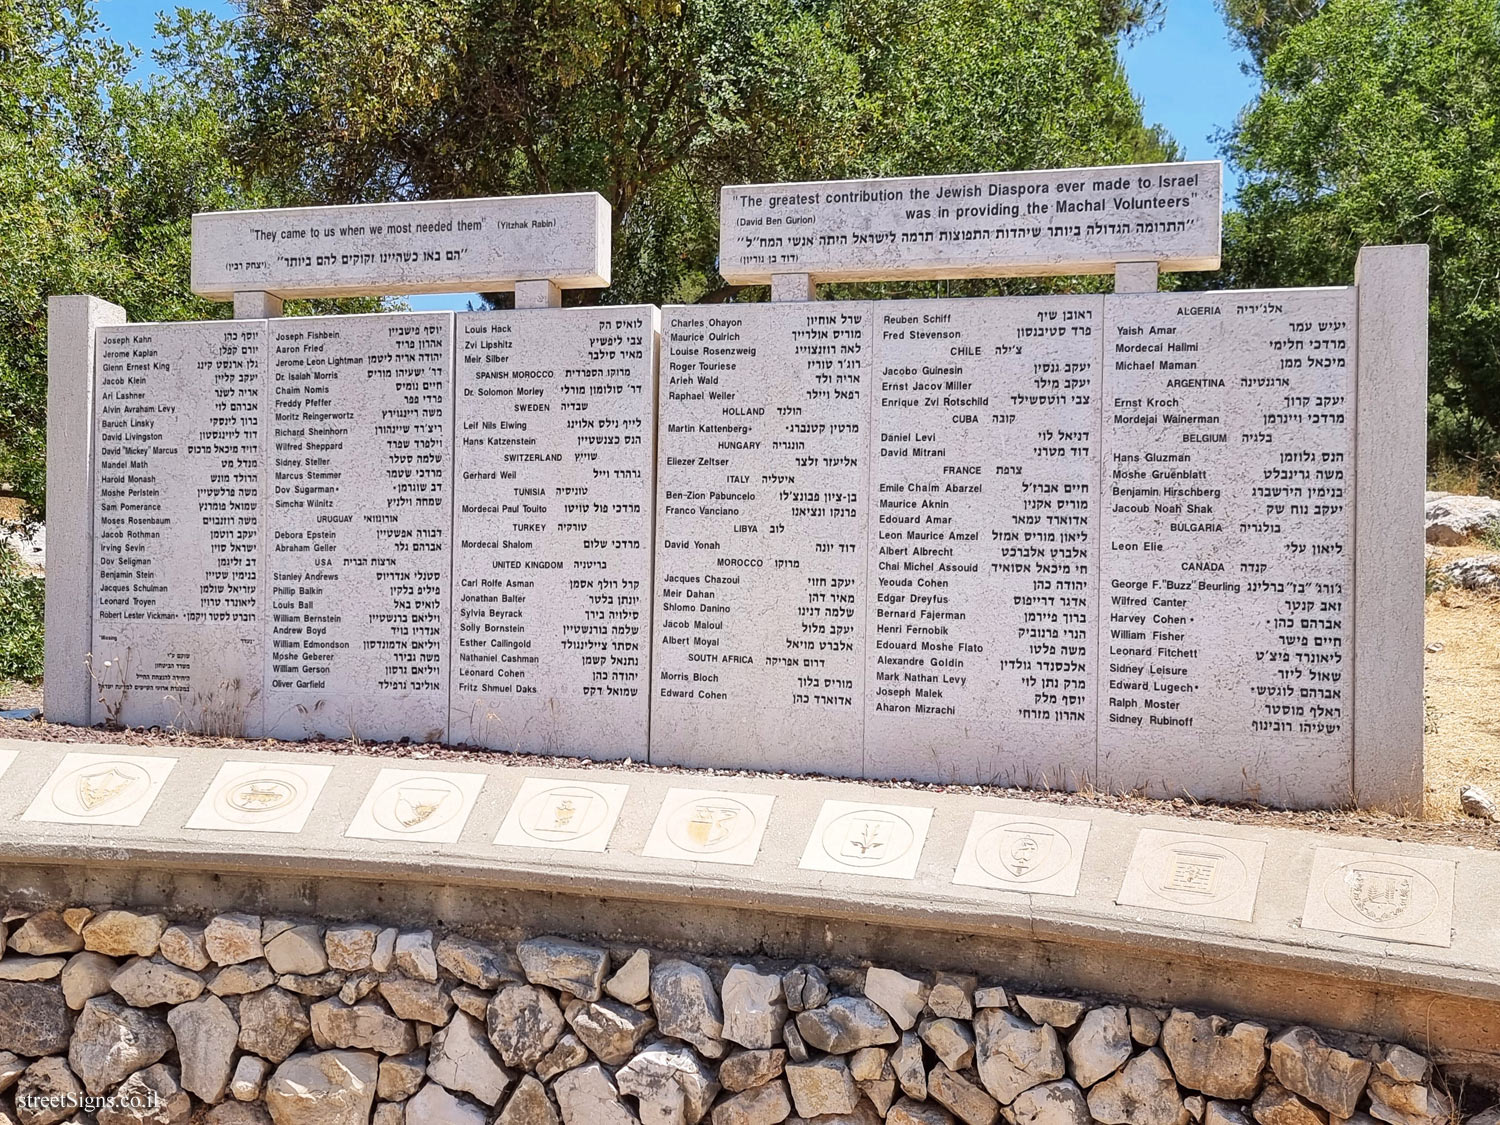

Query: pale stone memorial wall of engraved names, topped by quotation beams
[50,164,1425,804]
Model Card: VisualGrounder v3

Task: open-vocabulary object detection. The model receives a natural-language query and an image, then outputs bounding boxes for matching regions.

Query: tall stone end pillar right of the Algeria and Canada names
[1353,246,1428,813]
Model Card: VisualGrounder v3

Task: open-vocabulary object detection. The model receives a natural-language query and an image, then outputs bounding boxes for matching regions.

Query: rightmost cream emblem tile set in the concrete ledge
[1302,848,1457,948]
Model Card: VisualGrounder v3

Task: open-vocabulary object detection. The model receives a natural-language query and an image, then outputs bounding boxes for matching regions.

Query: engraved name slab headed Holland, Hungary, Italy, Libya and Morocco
[651,302,873,776]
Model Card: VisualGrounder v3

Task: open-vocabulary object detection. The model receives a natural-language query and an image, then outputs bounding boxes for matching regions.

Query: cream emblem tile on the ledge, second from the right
[1116,828,1266,923]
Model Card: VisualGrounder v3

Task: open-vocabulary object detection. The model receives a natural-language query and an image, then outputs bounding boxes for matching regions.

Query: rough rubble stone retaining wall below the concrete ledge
[0,906,1500,1125]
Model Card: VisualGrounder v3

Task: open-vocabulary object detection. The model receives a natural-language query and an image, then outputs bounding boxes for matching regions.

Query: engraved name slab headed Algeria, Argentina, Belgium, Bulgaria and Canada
[1100,288,1355,806]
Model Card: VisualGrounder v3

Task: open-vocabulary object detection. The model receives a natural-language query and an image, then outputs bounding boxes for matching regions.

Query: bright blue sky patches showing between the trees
[99,0,1256,309]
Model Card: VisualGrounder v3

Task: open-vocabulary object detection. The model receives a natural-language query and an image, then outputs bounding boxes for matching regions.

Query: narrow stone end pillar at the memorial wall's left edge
[42,297,125,726]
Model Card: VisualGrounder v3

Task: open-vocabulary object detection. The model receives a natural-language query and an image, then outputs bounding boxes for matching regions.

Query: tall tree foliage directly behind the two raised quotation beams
[177,0,1175,303]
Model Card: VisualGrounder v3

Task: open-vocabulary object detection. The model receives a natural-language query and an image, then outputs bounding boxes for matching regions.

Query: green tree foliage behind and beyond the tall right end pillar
[1218,0,1500,456]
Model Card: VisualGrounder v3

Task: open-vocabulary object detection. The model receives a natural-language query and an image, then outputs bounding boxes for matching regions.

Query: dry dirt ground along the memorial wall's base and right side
[0,548,1500,851]
